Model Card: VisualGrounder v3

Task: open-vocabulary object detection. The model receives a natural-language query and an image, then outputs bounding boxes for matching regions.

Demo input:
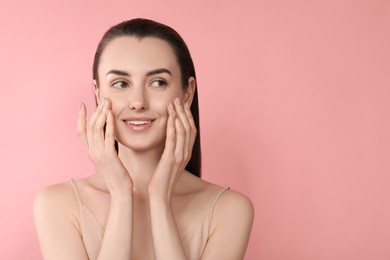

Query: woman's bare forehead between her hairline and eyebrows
[99,36,179,76]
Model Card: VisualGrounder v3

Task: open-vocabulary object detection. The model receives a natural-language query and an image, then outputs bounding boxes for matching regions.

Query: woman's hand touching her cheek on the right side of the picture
[148,98,197,203]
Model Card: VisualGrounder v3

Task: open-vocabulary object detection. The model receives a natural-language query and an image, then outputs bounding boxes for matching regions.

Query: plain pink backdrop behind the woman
[0,0,390,260]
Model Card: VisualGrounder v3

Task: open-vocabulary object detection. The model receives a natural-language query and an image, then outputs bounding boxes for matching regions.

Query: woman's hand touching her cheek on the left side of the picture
[77,98,133,195]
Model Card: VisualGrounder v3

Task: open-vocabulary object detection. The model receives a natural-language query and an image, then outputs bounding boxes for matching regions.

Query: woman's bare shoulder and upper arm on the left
[34,181,88,259]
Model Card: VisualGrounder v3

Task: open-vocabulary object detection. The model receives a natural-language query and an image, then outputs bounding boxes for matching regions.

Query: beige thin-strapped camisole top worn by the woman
[70,179,229,260]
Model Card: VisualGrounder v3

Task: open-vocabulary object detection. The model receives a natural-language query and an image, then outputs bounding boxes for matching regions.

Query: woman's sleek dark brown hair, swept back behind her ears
[92,18,201,177]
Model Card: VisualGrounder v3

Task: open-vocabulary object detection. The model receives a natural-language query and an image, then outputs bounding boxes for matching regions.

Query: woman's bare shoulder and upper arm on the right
[184,175,254,259]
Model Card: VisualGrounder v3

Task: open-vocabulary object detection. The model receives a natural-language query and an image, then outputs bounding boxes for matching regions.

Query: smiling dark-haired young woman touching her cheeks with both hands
[34,19,253,260]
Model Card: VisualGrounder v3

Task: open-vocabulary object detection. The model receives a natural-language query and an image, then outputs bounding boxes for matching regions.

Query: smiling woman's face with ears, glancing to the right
[96,37,195,150]
